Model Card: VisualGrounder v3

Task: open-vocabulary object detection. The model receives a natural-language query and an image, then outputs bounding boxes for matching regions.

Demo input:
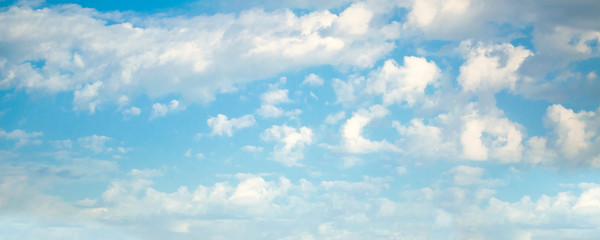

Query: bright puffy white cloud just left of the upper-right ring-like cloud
[366,57,440,106]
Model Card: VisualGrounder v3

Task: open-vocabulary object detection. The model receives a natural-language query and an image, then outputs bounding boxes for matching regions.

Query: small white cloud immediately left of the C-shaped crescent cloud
[261,125,313,167]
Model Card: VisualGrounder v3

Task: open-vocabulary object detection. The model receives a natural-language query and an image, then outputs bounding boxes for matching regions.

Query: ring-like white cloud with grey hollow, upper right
[458,41,533,92]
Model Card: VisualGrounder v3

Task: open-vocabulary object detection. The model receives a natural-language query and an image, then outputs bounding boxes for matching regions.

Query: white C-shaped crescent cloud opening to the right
[341,105,398,154]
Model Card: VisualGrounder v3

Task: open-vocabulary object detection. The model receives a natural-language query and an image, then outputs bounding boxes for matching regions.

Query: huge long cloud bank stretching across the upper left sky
[0,4,393,112]
